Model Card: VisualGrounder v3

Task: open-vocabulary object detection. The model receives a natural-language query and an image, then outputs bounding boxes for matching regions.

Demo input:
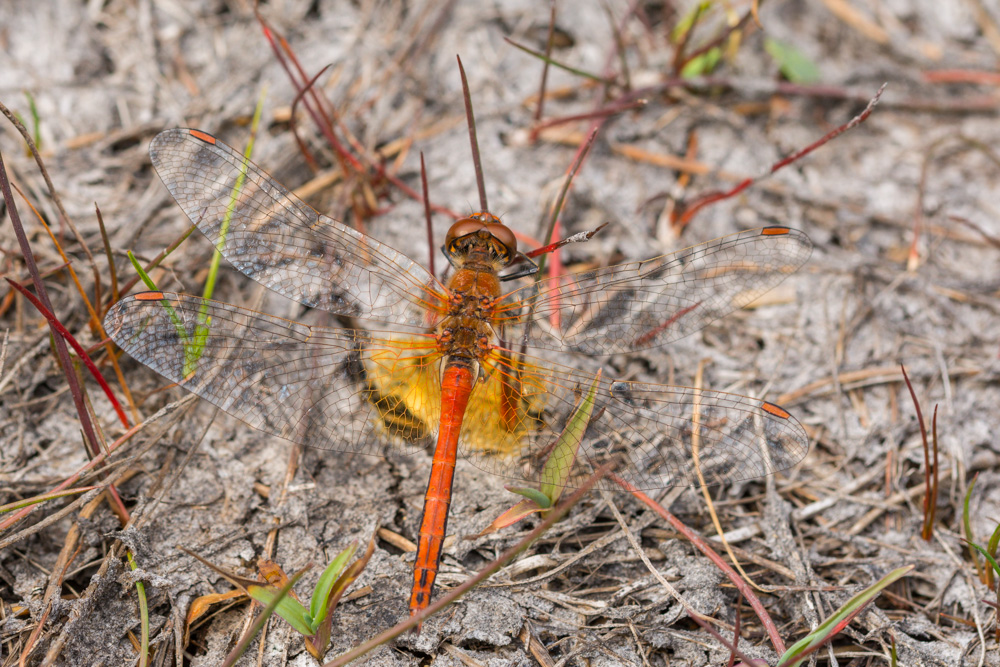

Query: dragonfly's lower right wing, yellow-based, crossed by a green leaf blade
[459,357,809,489]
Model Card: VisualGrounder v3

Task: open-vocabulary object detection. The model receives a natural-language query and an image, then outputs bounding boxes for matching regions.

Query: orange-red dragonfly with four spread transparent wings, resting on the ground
[105,129,812,614]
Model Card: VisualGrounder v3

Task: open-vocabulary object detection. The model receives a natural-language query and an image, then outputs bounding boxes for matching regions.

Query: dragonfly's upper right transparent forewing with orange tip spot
[497,227,812,354]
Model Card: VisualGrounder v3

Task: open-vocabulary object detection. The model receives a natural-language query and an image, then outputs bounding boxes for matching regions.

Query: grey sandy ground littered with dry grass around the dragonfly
[0,0,1000,666]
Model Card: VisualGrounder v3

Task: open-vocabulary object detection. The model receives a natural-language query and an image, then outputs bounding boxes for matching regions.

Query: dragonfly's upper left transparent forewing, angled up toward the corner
[149,129,439,327]
